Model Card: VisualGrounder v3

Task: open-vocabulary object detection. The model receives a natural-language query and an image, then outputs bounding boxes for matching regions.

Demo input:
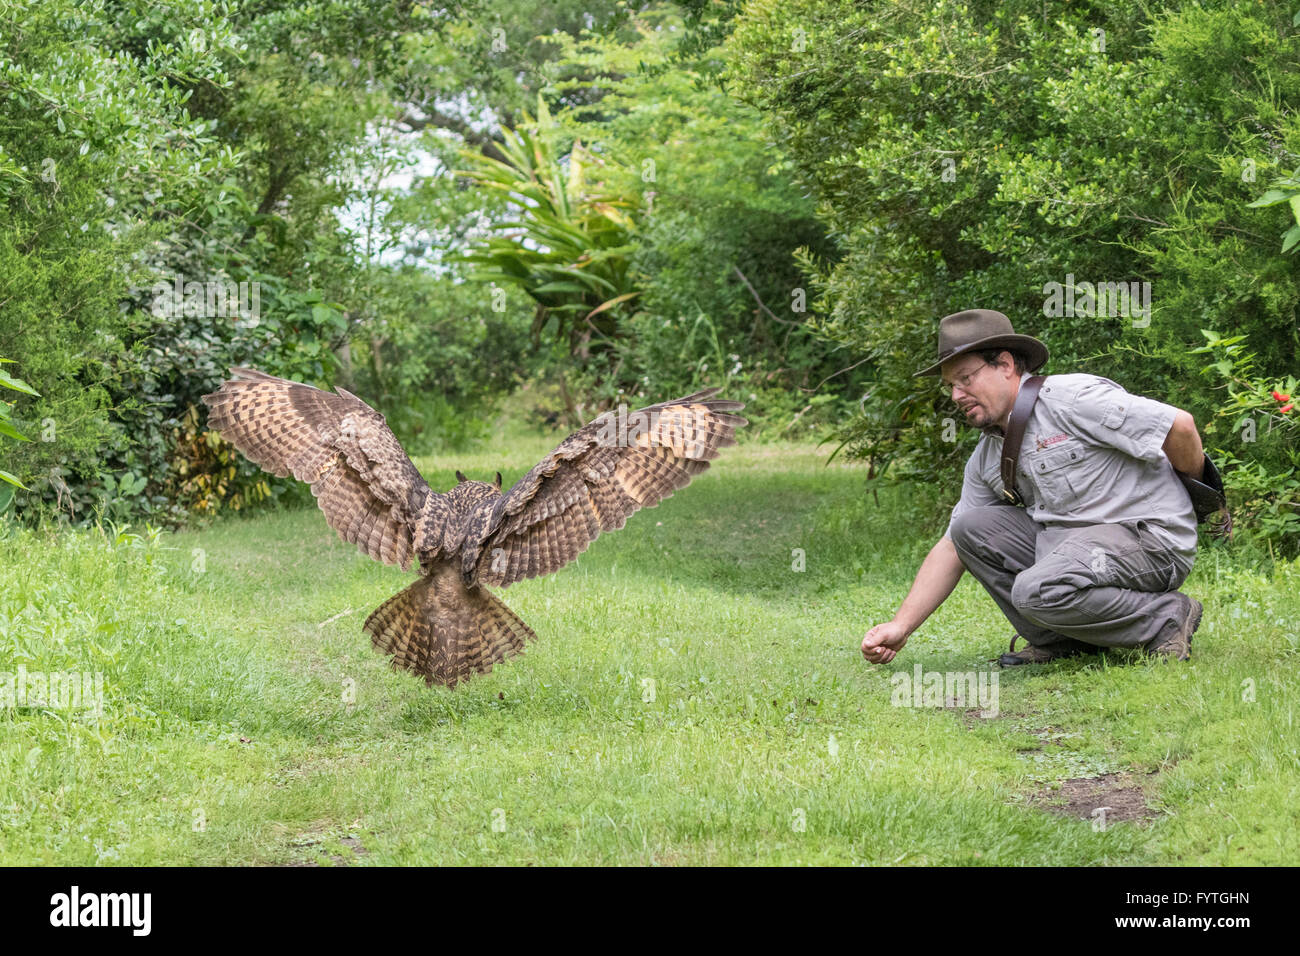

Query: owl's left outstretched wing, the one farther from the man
[203,368,447,570]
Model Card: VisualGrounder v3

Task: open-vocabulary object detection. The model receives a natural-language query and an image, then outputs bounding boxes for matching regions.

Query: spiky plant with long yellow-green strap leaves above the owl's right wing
[456,98,641,416]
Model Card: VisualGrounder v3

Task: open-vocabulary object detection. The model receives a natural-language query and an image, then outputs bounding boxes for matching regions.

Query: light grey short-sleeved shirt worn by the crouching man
[944,372,1196,570]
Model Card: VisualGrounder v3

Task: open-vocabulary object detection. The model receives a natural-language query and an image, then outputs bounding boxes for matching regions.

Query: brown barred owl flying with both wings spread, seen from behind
[203,368,749,687]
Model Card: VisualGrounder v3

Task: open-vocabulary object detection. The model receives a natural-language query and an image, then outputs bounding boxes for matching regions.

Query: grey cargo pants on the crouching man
[949,505,1192,650]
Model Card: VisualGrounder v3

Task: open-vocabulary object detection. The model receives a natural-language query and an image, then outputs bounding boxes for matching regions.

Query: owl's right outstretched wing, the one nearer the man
[462,389,749,587]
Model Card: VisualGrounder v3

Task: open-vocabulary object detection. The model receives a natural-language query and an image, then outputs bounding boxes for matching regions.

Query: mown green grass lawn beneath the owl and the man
[0,426,1300,865]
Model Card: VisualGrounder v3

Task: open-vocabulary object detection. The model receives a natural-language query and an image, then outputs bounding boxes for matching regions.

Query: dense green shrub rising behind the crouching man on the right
[727,0,1300,554]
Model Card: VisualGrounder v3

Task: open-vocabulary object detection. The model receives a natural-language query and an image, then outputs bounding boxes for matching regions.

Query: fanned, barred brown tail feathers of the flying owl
[365,563,537,687]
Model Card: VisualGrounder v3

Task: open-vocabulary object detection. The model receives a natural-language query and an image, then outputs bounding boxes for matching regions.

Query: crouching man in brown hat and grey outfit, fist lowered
[862,310,1204,666]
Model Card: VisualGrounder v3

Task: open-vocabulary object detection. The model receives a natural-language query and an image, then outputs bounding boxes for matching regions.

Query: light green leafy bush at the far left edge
[0,0,238,516]
